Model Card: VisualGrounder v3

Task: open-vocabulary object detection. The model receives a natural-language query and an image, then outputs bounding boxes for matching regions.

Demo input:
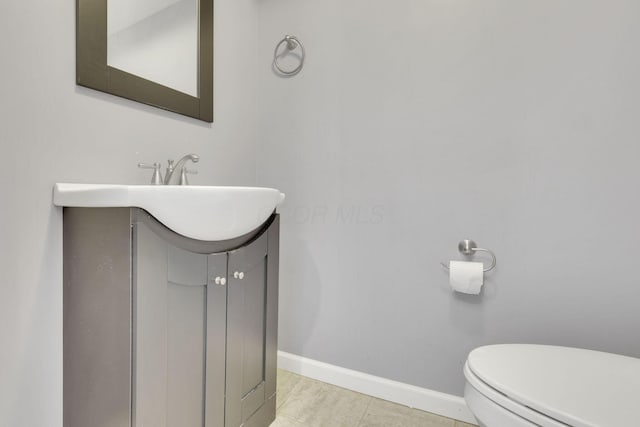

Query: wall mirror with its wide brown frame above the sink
[76,0,213,122]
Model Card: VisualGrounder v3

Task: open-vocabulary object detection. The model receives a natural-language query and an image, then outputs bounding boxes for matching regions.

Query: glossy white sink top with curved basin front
[53,183,284,240]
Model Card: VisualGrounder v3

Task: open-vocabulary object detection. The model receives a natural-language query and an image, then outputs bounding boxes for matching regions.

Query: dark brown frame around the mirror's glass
[76,0,213,123]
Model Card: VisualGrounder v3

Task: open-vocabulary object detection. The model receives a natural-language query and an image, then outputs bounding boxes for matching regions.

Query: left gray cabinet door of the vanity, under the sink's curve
[132,223,227,427]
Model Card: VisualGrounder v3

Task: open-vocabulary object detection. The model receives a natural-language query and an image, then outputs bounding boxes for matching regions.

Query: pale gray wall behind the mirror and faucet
[0,0,260,427]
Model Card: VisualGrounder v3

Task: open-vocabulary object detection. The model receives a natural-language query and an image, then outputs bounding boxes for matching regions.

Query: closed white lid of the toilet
[467,344,640,427]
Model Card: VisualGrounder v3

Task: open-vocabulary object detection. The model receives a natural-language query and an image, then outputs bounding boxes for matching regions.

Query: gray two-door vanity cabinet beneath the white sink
[54,185,283,427]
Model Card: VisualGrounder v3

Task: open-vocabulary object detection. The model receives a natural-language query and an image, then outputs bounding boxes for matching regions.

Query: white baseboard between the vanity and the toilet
[278,351,476,424]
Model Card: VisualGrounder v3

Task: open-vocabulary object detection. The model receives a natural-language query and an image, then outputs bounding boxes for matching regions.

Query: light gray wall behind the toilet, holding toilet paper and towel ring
[258,0,640,395]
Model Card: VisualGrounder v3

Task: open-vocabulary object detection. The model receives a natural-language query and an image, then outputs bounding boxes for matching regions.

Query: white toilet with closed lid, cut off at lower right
[464,344,640,427]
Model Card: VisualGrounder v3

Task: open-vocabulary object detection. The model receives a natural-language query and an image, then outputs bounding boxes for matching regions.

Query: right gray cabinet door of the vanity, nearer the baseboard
[225,219,278,427]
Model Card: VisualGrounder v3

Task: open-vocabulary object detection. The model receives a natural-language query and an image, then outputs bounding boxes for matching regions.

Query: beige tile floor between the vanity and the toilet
[271,369,472,427]
